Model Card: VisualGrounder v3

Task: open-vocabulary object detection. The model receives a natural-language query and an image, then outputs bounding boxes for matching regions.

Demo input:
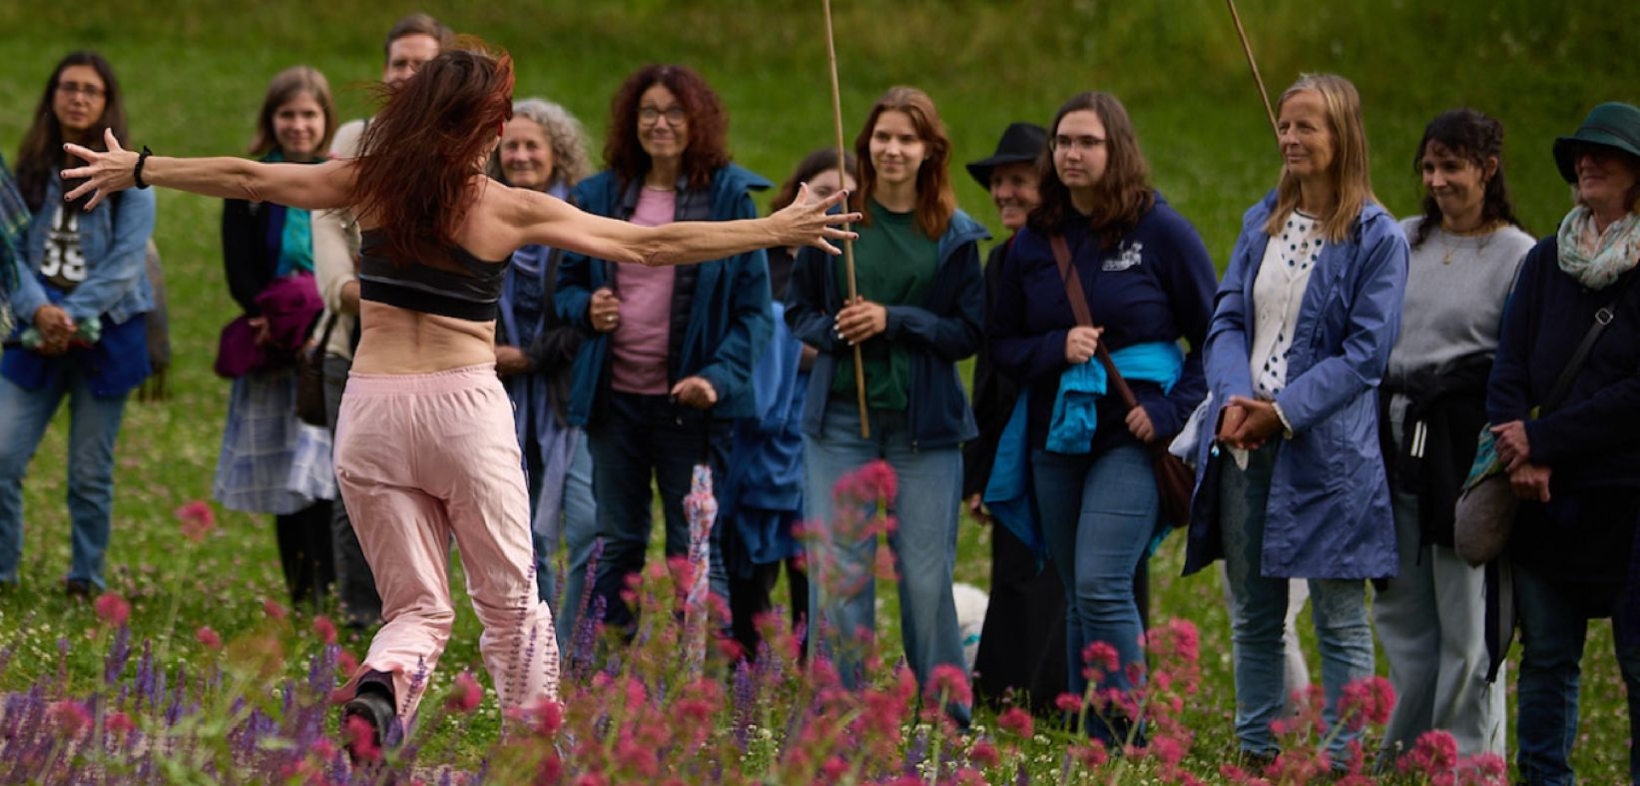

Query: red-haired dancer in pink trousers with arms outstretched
[66,49,858,743]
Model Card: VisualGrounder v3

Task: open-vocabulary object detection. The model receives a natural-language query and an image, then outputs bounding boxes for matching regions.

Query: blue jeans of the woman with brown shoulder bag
[1032,445,1159,742]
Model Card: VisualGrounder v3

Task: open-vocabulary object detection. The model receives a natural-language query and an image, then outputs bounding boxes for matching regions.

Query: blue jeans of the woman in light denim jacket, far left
[0,366,126,589]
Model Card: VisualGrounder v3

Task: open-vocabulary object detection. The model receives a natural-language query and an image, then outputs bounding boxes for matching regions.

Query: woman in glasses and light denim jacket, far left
[0,51,154,596]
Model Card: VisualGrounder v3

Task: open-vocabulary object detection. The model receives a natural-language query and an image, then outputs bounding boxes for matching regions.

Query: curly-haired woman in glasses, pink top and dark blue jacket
[554,66,774,643]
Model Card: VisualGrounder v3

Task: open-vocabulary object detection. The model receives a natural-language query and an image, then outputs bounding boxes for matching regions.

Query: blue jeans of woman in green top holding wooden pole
[804,399,968,722]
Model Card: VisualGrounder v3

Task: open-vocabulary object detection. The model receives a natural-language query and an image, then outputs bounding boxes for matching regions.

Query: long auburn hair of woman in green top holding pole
[848,87,956,240]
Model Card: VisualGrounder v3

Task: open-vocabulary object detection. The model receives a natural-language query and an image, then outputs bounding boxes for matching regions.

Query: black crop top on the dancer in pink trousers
[359,228,510,322]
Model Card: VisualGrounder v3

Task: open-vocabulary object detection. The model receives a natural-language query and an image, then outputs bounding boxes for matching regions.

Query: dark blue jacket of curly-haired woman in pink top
[553,164,774,425]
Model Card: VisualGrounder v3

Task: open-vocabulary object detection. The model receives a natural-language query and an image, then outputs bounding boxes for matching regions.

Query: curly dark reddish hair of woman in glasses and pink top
[604,66,730,189]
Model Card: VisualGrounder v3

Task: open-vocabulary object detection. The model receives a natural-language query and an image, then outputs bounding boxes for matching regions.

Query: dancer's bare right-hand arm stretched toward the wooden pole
[508,183,859,267]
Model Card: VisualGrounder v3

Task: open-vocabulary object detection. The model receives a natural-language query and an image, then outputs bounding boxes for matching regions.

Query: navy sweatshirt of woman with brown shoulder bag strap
[986,194,1219,455]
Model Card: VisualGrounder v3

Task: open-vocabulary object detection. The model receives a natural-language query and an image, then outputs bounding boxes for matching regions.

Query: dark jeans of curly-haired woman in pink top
[585,391,730,630]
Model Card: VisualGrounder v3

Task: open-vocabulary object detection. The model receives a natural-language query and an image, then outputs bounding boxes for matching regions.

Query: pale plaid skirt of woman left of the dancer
[212,368,336,515]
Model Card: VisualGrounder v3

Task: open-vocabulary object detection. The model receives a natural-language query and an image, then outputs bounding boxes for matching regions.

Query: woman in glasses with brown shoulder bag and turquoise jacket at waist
[989,92,1217,745]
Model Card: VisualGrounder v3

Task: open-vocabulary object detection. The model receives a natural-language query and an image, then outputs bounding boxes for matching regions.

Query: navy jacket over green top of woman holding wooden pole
[786,210,991,448]
